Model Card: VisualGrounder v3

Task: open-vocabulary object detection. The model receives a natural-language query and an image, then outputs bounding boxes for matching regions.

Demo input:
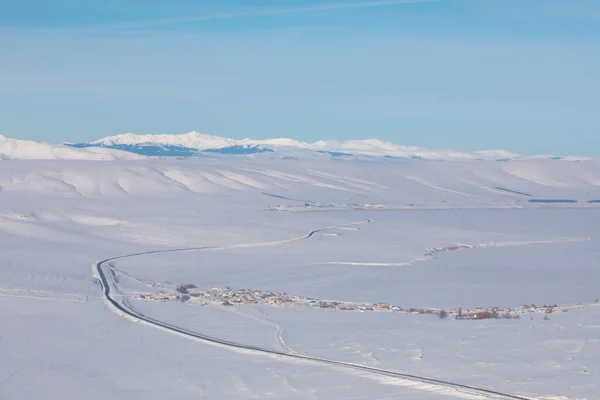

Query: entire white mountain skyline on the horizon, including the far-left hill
[0,132,588,161]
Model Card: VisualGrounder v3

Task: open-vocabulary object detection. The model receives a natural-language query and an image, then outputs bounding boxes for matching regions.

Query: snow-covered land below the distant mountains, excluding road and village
[0,138,600,400]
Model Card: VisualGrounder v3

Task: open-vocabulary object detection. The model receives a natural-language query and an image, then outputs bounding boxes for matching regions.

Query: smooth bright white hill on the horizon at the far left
[0,135,142,160]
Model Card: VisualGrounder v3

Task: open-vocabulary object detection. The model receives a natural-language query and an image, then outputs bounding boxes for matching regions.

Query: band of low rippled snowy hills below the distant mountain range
[0,154,600,208]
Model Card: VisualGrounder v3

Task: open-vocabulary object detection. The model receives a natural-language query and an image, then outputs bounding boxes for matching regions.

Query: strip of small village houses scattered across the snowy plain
[134,282,580,320]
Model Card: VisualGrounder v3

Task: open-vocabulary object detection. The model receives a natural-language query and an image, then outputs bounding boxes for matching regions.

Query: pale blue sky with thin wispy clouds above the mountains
[0,0,600,156]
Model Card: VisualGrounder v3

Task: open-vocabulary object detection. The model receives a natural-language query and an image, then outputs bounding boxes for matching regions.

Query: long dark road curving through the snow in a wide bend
[92,220,532,400]
